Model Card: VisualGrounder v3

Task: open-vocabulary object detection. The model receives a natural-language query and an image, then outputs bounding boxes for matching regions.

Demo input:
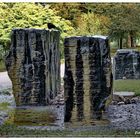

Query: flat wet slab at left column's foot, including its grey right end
[13,106,64,127]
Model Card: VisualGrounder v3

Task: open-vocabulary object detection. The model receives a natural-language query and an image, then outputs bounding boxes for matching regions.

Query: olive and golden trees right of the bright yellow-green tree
[51,3,140,48]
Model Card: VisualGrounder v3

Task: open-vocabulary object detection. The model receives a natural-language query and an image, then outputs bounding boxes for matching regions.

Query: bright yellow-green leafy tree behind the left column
[0,3,73,59]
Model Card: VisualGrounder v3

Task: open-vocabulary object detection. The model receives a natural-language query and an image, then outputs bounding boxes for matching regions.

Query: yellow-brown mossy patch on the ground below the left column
[14,108,56,126]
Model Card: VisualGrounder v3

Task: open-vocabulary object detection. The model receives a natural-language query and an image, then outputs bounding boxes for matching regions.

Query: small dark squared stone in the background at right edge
[114,49,140,79]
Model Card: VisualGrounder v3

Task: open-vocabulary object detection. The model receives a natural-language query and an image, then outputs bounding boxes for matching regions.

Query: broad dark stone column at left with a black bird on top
[6,29,60,106]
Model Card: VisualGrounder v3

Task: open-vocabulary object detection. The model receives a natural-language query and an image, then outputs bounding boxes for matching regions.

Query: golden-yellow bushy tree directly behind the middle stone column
[76,13,109,35]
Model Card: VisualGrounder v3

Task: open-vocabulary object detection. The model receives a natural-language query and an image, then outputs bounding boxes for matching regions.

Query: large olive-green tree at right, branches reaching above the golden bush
[80,3,140,48]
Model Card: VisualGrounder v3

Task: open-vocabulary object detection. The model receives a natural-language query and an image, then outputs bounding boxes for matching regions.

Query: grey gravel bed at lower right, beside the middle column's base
[108,103,140,130]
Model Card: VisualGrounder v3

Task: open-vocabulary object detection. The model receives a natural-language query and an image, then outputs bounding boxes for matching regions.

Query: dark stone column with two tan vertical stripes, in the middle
[64,36,112,122]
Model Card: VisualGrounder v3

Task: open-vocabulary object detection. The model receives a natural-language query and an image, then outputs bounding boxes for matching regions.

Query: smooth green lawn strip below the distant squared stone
[114,80,140,96]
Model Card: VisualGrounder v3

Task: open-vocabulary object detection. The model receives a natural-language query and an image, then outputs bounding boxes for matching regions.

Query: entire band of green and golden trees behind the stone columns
[0,3,140,62]
